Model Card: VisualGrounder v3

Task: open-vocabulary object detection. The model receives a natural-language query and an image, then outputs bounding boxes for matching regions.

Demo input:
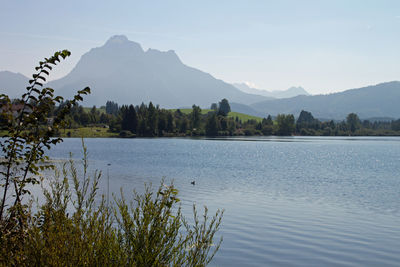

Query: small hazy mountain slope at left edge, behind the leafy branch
[0,71,29,98]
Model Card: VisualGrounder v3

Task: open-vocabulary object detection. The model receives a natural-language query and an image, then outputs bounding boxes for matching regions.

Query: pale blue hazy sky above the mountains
[0,0,400,94]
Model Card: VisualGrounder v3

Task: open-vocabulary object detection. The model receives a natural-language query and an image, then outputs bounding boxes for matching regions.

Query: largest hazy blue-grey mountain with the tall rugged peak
[48,35,267,108]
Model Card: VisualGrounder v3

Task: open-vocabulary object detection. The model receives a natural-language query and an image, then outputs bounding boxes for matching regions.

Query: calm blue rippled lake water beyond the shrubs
[44,137,400,266]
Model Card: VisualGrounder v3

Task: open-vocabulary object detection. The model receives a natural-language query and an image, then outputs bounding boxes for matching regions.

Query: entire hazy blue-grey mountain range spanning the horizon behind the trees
[0,36,400,119]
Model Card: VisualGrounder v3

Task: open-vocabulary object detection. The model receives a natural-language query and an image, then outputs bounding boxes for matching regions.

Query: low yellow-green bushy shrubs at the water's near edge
[0,147,222,266]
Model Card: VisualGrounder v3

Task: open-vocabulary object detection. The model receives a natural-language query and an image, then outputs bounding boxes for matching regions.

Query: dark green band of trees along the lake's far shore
[49,99,400,137]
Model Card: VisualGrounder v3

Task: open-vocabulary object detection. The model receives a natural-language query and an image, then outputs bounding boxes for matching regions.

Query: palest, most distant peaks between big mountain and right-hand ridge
[232,83,310,98]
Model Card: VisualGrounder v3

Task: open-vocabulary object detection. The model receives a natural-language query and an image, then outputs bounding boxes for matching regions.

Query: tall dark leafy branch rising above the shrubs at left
[0,50,90,234]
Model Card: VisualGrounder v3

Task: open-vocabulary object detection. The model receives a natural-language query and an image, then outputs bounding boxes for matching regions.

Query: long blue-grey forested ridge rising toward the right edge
[250,81,400,120]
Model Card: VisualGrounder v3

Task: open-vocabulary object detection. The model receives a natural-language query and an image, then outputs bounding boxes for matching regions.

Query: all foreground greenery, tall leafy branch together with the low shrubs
[0,50,222,266]
